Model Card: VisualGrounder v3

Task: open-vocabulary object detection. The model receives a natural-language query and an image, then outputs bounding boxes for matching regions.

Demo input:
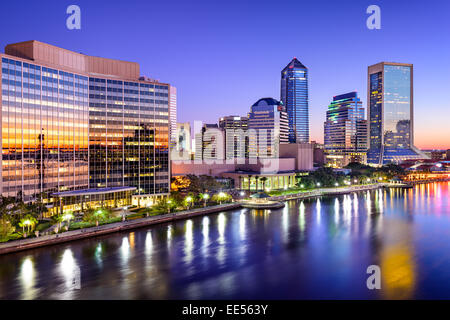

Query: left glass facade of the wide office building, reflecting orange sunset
[1,56,89,201]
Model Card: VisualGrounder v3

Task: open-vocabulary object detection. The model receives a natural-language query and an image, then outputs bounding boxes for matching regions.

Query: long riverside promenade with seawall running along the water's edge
[0,184,383,254]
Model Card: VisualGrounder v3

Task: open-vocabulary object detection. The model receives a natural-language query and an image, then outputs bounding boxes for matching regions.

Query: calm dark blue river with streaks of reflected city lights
[0,183,450,299]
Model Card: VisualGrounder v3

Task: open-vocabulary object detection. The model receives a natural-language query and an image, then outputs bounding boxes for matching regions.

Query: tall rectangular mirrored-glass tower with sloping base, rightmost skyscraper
[367,62,427,165]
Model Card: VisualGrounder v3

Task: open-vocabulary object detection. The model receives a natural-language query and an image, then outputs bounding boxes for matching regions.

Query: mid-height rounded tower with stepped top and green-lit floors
[324,92,367,167]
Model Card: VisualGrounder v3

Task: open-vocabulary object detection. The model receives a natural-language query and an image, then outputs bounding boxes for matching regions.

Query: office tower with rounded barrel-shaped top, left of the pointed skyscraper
[248,98,289,158]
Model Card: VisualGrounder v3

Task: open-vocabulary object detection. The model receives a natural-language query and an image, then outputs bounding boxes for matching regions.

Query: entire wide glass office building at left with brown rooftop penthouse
[0,41,170,210]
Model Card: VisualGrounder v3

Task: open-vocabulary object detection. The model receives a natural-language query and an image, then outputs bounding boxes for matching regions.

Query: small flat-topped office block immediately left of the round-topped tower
[219,116,249,159]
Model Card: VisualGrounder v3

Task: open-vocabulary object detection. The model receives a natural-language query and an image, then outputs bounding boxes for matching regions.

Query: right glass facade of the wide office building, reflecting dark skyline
[89,78,169,195]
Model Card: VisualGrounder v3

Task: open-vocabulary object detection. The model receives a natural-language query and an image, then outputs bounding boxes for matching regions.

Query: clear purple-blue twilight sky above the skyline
[0,0,450,148]
